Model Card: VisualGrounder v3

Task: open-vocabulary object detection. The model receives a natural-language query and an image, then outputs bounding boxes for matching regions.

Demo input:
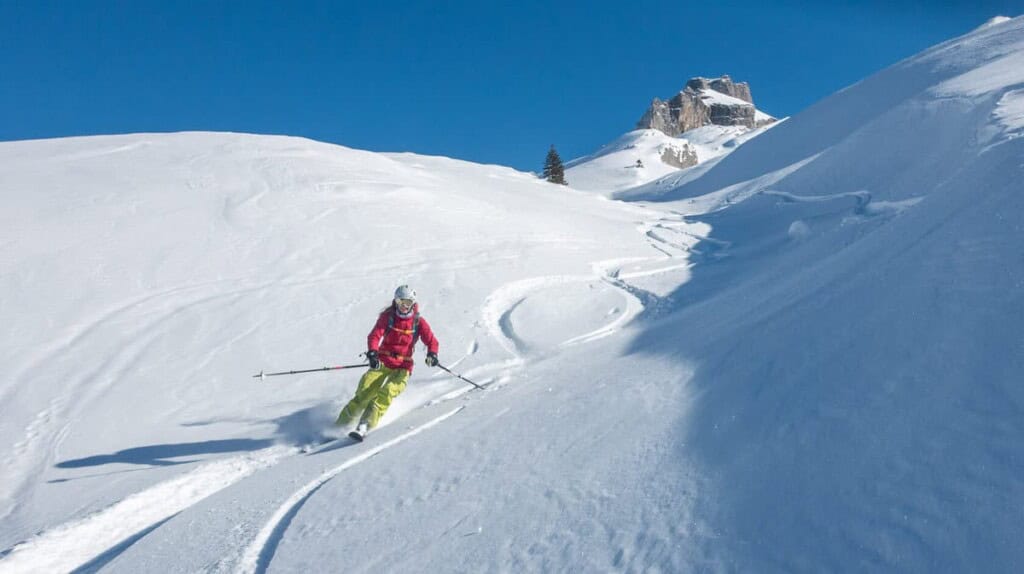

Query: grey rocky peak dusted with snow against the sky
[637,76,775,137]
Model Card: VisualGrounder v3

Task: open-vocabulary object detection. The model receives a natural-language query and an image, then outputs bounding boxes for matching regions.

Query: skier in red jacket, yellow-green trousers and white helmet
[335,285,438,441]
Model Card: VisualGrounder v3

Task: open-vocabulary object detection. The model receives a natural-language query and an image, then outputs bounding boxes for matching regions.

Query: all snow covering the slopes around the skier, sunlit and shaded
[0,13,1024,573]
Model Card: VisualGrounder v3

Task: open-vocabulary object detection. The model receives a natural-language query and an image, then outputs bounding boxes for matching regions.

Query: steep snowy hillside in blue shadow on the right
[632,18,1024,572]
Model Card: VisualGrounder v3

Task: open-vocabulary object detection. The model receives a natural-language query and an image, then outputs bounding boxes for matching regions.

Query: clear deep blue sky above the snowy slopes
[0,0,1024,170]
